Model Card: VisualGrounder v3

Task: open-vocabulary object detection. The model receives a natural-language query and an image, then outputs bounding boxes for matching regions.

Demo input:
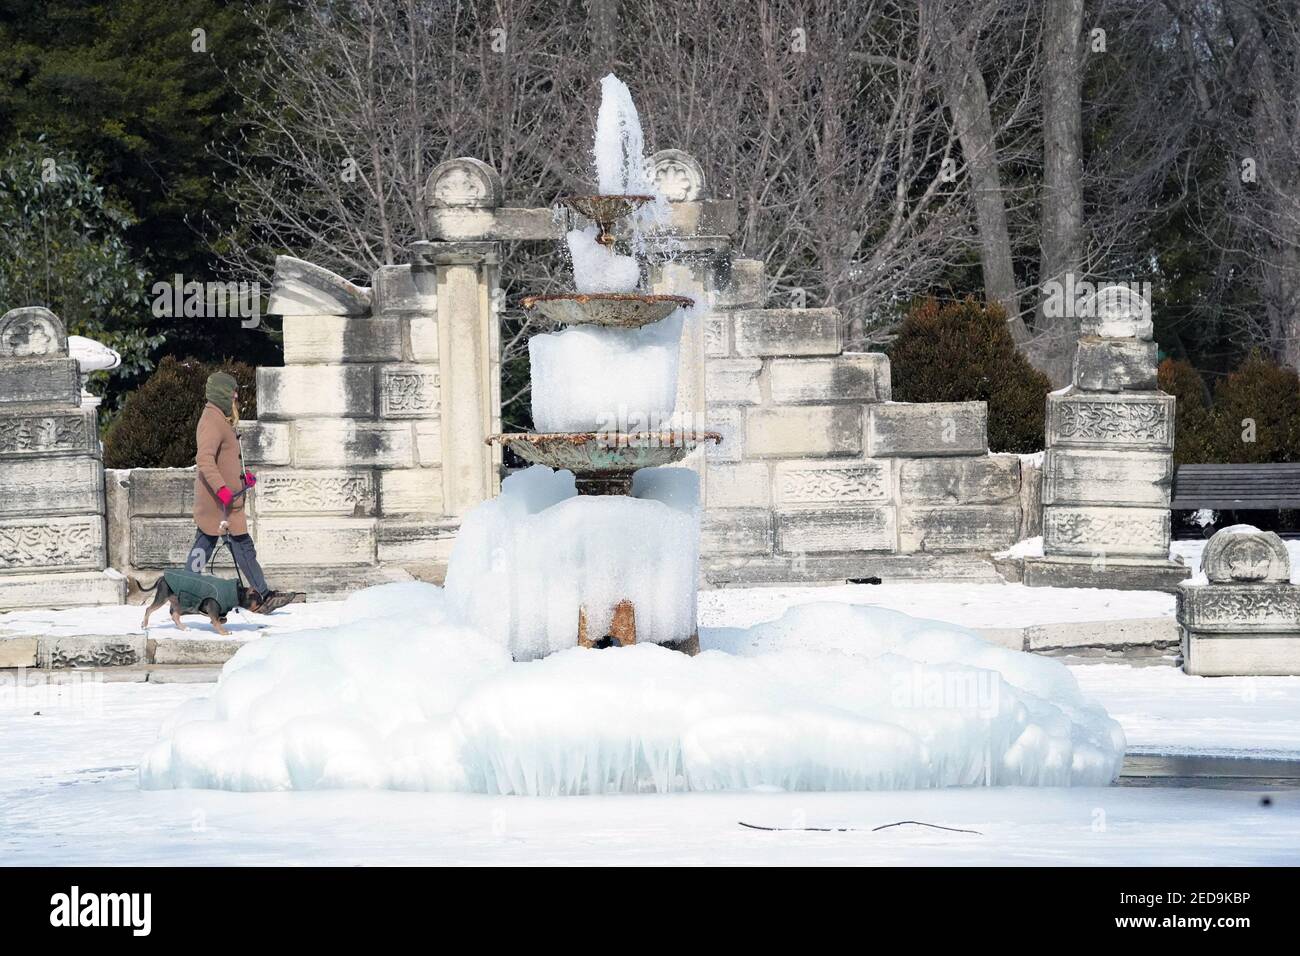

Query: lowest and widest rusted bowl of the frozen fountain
[488,432,723,494]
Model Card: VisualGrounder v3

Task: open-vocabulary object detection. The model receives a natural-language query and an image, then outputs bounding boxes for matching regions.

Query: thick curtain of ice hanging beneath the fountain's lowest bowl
[447,466,699,661]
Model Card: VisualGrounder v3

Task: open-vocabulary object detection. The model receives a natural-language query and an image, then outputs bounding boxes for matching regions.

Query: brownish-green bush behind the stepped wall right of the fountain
[889,299,1052,453]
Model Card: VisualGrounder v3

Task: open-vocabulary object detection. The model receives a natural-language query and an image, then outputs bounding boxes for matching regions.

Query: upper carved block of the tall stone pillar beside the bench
[1047,389,1174,451]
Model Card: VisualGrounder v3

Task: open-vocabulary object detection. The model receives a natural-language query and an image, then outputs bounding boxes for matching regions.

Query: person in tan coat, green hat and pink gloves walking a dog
[189,372,295,614]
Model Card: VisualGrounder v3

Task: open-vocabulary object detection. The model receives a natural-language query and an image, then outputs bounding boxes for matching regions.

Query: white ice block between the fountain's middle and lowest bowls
[528,310,685,432]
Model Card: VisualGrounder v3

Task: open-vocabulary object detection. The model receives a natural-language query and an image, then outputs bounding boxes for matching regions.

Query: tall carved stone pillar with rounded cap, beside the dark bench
[1024,286,1188,589]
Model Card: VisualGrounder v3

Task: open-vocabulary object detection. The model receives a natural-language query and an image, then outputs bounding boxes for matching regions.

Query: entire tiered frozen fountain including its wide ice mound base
[140,77,1125,796]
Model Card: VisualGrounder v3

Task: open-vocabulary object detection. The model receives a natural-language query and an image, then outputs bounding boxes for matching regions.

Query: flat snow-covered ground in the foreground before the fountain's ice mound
[0,681,1300,866]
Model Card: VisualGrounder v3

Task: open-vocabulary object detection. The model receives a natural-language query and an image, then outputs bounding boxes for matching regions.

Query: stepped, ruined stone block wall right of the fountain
[703,259,1028,584]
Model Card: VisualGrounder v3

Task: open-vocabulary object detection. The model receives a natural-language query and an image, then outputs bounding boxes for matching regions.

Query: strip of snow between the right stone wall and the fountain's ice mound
[699,581,1174,628]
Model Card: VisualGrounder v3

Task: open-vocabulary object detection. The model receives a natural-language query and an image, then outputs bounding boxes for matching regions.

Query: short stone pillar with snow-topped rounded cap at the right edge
[1178,524,1300,678]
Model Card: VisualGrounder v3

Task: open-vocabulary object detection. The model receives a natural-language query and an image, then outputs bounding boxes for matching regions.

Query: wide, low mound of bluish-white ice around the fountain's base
[140,567,1125,795]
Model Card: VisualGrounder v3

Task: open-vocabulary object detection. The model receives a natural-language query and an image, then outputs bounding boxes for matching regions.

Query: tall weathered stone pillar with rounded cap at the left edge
[0,306,126,610]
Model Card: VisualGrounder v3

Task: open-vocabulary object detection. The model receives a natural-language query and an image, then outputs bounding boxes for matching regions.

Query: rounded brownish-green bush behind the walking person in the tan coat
[104,355,257,468]
